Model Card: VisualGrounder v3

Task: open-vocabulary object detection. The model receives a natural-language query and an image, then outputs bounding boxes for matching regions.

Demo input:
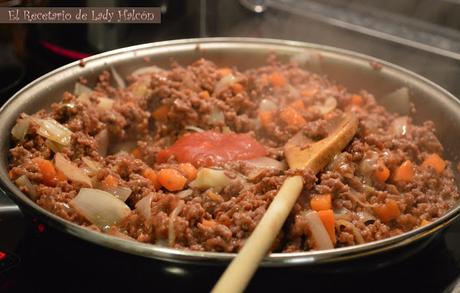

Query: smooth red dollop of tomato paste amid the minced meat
[156,131,268,167]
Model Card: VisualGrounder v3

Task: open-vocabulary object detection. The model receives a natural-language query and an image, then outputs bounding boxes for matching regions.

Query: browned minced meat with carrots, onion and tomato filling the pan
[9,58,458,252]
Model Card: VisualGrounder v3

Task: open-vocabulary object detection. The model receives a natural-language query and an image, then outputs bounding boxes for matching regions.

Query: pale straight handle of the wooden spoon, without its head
[212,176,303,293]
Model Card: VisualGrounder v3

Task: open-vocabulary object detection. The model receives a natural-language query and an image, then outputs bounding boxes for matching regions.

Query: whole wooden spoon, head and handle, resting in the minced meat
[212,113,358,293]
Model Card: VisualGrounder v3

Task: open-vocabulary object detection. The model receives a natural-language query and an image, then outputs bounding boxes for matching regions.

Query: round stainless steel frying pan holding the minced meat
[0,38,460,266]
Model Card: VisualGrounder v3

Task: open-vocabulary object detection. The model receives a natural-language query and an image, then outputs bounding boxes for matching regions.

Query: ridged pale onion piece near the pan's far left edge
[30,117,72,146]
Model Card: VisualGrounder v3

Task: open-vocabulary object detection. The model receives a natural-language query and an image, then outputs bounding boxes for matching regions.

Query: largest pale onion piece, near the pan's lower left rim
[70,188,131,229]
